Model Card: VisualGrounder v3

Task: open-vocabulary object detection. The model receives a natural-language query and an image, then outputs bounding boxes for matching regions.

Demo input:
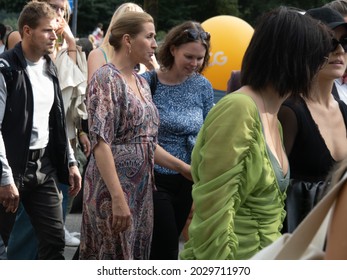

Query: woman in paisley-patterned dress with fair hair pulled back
[80,12,190,260]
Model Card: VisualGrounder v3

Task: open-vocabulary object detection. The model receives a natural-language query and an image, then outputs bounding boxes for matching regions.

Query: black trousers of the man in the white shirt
[0,153,65,260]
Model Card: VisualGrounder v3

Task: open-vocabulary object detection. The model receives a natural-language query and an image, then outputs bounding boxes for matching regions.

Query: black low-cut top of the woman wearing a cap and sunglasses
[283,98,347,182]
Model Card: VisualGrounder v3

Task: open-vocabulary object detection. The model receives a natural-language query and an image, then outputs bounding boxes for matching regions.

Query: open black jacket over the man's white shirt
[0,43,69,184]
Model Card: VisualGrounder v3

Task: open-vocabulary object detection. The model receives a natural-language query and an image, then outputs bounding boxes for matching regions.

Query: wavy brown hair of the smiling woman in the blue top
[157,21,210,73]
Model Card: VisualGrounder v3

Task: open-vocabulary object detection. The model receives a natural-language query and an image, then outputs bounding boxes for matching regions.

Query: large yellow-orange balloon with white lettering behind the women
[201,16,254,91]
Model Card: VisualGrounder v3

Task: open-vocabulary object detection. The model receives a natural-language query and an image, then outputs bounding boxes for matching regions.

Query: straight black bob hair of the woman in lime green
[241,6,333,97]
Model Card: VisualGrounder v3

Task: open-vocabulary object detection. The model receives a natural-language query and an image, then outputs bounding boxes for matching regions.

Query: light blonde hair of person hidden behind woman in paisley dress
[100,2,144,61]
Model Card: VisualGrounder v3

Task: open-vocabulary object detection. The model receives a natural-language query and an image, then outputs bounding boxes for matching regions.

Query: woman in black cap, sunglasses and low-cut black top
[279,7,347,232]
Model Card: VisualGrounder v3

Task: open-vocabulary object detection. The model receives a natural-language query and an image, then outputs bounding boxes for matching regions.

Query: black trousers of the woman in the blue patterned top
[150,173,193,260]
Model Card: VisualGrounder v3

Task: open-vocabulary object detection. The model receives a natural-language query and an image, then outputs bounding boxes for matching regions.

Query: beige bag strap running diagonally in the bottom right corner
[275,172,347,260]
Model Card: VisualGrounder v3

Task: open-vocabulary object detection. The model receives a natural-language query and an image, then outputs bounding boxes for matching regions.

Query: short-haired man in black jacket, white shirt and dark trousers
[0,2,81,259]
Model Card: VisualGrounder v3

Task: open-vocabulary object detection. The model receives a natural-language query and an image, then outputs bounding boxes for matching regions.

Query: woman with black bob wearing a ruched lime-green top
[180,7,331,260]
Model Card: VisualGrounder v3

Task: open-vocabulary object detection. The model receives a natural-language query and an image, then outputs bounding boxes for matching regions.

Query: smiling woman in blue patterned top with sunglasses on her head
[143,21,214,260]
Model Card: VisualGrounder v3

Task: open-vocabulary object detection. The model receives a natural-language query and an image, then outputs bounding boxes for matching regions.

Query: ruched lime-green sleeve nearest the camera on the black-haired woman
[180,94,264,260]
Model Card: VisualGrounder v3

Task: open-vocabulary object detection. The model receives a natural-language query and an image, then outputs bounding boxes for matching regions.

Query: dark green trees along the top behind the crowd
[0,0,329,39]
